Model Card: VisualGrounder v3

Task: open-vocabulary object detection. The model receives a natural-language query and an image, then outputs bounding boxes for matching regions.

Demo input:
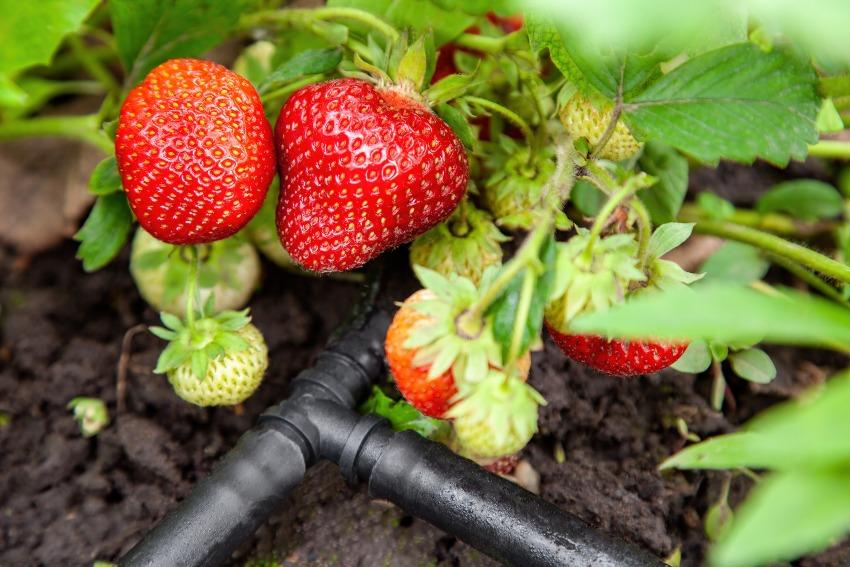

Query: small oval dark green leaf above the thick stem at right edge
[756,179,844,220]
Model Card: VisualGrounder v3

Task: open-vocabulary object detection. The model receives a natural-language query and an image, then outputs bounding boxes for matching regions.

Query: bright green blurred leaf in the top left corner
[0,0,99,79]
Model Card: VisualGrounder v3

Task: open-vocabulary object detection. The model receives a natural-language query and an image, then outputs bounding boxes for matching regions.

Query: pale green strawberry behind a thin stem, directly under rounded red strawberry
[130,228,260,317]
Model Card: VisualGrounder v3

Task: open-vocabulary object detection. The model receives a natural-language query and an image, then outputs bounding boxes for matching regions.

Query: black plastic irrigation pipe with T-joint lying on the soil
[118,312,664,567]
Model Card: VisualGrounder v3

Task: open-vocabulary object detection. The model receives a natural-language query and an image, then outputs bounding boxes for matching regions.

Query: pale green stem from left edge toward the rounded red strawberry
[0,114,113,154]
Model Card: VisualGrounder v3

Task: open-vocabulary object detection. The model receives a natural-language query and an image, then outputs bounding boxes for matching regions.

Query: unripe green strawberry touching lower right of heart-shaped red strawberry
[410,201,509,284]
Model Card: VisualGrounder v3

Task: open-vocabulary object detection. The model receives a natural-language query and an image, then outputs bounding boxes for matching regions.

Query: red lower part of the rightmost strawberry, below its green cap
[546,323,688,376]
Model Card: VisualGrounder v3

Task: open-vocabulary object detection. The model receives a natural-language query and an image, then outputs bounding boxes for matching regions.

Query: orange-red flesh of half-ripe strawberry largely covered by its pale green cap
[384,289,531,418]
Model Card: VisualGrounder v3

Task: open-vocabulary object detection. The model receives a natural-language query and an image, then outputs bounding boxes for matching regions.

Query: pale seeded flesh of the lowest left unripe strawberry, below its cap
[168,324,269,406]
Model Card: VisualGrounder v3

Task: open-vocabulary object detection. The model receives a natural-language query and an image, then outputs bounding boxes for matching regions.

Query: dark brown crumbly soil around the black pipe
[0,162,850,567]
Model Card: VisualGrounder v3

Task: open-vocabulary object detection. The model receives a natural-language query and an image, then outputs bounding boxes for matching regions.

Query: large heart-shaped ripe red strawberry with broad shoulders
[275,79,469,272]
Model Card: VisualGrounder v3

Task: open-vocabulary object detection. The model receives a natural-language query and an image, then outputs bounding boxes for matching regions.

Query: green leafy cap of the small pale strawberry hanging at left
[150,309,251,380]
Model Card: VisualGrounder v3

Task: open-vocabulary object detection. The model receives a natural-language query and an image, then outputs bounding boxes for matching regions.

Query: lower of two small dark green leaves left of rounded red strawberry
[74,193,133,272]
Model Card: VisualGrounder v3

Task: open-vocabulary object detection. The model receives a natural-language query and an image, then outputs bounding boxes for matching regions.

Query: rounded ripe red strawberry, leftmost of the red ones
[115,59,275,244]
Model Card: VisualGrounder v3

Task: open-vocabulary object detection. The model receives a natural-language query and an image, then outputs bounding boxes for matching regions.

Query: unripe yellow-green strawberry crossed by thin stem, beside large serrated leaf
[559,93,640,161]
